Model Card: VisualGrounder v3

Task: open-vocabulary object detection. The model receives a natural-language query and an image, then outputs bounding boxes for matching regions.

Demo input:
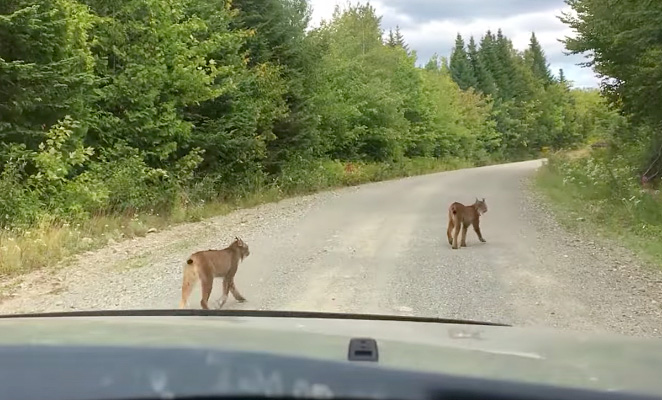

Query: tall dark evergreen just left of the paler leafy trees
[184,0,288,180]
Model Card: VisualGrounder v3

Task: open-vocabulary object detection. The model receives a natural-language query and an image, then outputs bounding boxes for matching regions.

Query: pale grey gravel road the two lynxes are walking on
[0,161,662,336]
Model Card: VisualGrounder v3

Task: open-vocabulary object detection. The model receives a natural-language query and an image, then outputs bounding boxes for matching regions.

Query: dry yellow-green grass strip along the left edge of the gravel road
[0,158,478,277]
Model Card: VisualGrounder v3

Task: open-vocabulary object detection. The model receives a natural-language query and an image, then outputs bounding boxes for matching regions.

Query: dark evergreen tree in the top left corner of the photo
[0,0,94,150]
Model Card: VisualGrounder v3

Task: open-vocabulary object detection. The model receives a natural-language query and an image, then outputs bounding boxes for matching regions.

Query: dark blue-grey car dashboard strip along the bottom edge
[0,338,655,400]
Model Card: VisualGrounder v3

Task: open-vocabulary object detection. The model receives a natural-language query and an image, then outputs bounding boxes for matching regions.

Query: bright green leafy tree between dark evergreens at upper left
[82,0,235,168]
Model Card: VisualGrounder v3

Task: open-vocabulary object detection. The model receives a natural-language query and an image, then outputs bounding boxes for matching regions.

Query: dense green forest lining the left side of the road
[0,0,612,274]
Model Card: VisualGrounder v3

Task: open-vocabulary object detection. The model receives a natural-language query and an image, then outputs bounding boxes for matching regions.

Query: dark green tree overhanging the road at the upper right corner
[562,0,662,180]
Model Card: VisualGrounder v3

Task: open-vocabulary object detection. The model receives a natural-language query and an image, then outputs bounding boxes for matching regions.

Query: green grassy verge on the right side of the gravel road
[535,152,662,268]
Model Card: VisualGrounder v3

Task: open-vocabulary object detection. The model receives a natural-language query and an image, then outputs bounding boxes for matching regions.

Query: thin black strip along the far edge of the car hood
[0,309,511,327]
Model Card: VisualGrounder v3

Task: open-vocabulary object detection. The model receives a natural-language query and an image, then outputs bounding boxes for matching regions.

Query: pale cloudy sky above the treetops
[309,0,599,87]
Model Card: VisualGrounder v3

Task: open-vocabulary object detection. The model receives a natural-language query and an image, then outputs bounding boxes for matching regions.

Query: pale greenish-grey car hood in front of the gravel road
[0,315,662,395]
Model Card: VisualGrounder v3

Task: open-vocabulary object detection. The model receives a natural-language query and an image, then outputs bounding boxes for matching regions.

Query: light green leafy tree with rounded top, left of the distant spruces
[312,5,408,161]
